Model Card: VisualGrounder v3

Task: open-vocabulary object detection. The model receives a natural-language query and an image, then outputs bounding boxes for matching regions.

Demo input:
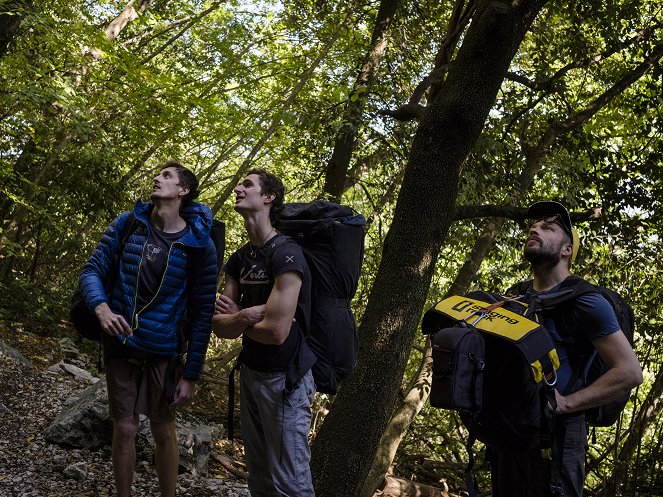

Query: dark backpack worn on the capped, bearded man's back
[507,276,635,426]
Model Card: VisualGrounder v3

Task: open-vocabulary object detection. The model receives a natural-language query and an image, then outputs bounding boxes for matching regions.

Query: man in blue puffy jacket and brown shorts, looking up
[80,161,217,497]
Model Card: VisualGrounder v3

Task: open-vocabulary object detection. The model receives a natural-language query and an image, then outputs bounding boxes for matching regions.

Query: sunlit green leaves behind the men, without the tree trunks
[0,0,663,496]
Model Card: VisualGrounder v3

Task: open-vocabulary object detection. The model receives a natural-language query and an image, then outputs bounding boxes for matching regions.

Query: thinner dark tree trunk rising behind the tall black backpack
[324,0,400,201]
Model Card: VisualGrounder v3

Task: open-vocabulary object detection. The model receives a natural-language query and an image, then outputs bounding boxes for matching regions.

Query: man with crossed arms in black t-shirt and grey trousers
[212,170,315,497]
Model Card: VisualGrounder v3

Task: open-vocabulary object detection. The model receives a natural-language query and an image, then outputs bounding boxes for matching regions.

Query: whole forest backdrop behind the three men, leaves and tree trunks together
[0,0,663,497]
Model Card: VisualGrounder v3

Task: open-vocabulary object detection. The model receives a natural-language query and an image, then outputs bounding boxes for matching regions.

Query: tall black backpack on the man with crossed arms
[275,200,366,394]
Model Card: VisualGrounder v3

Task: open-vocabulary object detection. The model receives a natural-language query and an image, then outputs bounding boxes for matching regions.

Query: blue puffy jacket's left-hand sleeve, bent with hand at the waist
[79,212,130,310]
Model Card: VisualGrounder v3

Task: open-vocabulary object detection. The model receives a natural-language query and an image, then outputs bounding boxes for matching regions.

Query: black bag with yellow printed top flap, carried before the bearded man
[421,292,559,496]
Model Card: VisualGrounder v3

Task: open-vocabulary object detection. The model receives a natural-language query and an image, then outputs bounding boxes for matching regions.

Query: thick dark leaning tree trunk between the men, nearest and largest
[311,0,545,497]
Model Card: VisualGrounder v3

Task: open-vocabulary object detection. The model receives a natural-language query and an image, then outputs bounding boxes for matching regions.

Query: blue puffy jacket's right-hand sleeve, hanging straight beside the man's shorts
[182,242,217,381]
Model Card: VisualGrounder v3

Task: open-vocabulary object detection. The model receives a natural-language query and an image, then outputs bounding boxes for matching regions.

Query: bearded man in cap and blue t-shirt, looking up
[491,201,642,497]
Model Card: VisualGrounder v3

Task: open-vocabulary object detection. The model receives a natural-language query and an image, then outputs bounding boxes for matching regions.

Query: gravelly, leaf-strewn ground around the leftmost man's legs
[0,322,248,497]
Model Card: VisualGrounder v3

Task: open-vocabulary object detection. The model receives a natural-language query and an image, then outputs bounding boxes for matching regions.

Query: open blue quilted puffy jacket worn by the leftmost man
[80,200,217,380]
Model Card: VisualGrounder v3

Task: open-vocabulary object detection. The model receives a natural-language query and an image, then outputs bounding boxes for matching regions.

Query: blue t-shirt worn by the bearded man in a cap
[529,283,620,394]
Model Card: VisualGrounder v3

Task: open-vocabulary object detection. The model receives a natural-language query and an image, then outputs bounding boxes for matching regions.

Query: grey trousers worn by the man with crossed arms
[240,366,315,497]
